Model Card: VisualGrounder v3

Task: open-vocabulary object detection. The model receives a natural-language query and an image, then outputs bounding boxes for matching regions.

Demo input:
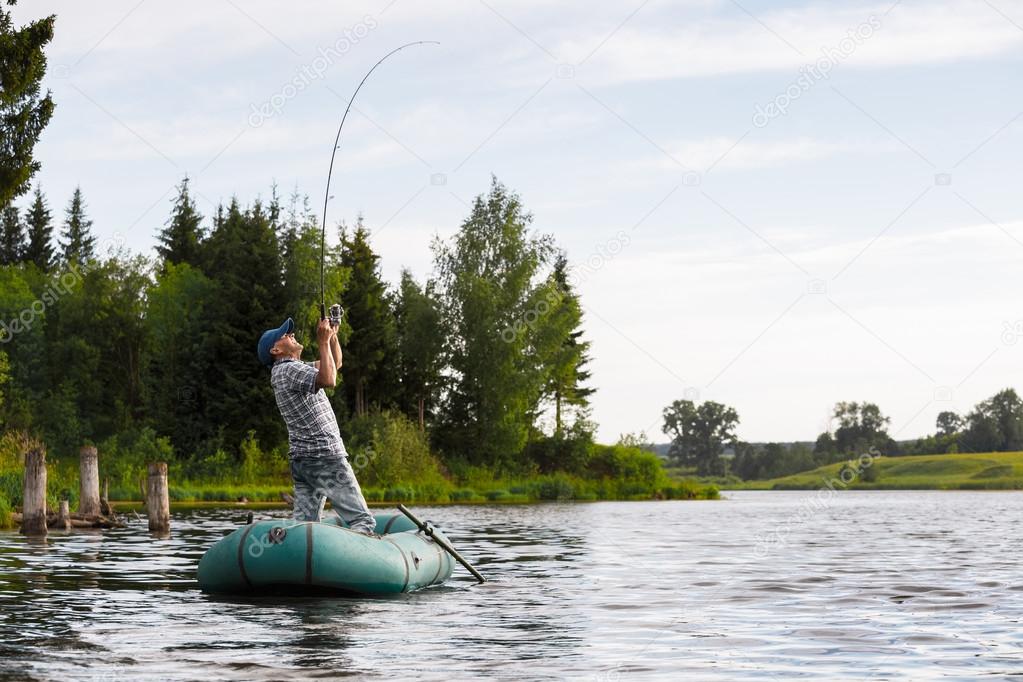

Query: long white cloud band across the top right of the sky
[558,0,1023,85]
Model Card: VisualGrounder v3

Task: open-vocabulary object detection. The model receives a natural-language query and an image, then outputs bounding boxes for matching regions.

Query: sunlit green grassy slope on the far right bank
[727,452,1023,490]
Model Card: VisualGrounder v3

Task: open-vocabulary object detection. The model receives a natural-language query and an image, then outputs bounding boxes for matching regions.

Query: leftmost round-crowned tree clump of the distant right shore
[662,400,739,475]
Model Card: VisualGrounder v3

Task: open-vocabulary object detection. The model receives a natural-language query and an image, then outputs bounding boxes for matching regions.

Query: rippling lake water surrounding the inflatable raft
[0,492,1023,681]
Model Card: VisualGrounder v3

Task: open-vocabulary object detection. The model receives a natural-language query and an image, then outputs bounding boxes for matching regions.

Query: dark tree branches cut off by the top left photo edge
[0,0,54,208]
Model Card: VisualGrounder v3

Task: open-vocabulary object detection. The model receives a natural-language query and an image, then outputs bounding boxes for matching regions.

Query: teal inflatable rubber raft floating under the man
[198,514,454,594]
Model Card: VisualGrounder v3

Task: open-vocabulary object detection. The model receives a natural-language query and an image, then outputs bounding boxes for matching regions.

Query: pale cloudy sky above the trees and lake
[13,0,1023,442]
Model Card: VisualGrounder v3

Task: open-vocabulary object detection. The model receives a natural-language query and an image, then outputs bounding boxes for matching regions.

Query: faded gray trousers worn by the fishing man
[291,455,376,534]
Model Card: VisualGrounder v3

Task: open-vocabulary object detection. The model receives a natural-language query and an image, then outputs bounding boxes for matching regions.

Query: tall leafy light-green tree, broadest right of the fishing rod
[434,178,552,469]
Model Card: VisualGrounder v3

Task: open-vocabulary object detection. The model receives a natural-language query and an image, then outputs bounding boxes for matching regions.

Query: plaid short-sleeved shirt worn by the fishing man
[270,359,348,457]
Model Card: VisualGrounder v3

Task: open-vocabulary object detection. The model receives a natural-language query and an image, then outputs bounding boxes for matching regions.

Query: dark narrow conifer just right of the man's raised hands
[341,216,397,415]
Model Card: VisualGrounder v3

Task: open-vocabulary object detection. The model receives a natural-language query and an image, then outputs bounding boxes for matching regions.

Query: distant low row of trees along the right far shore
[663,389,1023,481]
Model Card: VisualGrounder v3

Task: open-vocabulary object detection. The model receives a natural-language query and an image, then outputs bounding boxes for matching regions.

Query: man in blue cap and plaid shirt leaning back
[257,318,376,535]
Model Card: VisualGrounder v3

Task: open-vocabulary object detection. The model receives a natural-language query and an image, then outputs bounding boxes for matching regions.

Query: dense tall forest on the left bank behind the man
[0,178,593,470]
